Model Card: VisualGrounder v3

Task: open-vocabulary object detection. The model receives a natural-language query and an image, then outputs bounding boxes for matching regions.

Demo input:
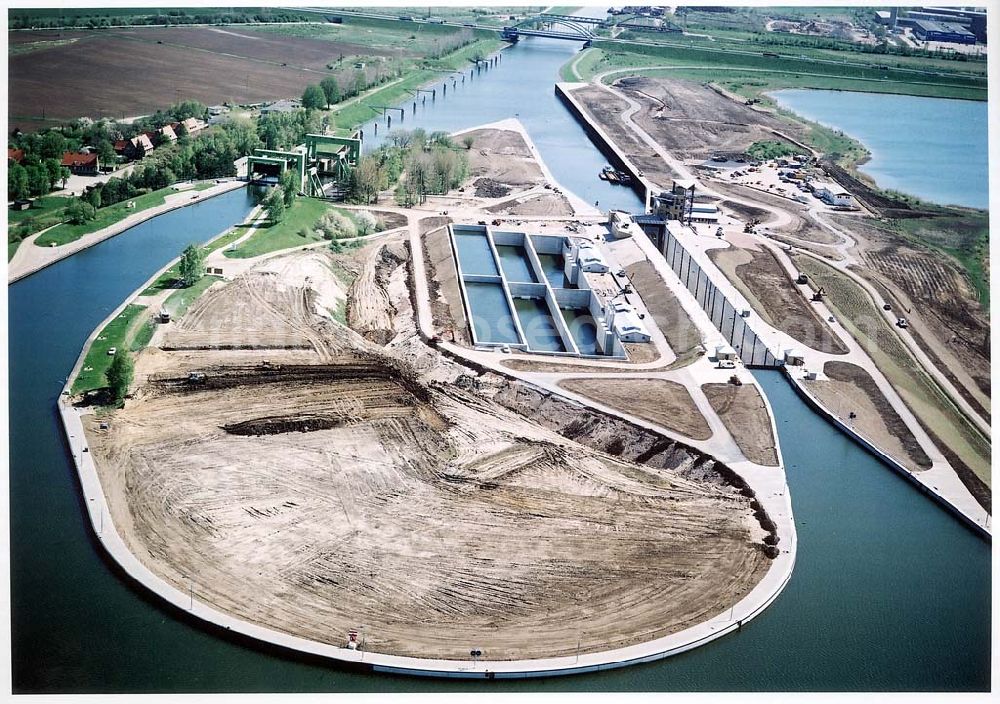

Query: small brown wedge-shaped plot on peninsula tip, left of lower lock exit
[701,384,778,466]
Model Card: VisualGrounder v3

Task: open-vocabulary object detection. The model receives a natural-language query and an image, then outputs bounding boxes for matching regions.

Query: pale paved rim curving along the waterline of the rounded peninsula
[57,118,797,679]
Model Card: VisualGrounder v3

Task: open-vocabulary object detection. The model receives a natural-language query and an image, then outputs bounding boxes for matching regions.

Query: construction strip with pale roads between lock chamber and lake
[557,77,991,532]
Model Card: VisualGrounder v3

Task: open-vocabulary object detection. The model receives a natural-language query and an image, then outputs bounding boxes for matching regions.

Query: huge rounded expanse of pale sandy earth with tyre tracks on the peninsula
[85,252,773,659]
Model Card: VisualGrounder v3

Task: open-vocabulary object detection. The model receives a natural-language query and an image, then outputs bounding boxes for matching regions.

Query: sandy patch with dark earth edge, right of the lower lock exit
[805,362,931,472]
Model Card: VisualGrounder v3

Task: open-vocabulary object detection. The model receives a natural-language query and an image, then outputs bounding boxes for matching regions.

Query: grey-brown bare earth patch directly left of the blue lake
[615,77,798,159]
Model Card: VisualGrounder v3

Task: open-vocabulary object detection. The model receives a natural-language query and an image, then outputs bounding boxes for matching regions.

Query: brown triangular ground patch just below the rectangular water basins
[559,379,712,440]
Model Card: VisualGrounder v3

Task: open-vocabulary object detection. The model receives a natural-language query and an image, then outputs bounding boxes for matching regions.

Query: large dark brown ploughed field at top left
[7,27,373,128]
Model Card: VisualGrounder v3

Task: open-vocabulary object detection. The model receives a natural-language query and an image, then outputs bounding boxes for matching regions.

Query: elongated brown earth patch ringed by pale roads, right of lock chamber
[708,247,847,354]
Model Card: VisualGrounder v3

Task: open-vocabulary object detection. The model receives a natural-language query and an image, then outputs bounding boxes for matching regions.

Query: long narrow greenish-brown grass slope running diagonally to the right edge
[793,254,991,486]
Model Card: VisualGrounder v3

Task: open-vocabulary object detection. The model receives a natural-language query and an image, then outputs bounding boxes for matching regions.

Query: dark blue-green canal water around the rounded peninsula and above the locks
[8,34,990,693]
